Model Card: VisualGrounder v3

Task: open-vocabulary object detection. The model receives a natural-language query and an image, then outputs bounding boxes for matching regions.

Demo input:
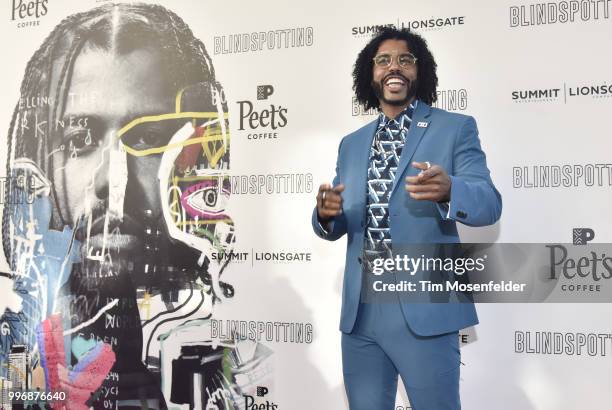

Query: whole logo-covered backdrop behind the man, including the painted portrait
[0,0,612,410]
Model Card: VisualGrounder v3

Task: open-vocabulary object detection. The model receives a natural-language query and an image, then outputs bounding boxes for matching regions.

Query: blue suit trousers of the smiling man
[342,303,461,410]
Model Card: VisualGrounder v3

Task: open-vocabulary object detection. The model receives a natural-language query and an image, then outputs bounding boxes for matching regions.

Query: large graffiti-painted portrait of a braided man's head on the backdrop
[0,4,271,409]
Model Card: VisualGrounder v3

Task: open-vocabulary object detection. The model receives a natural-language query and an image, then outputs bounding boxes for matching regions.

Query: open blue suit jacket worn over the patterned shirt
[312,101,502,336]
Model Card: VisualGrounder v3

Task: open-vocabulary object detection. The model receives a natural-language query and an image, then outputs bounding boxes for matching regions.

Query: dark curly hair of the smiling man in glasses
[353,26,438,110]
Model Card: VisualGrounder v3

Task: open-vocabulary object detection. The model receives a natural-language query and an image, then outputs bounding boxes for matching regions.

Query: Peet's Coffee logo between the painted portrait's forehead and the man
[236,85,287,141]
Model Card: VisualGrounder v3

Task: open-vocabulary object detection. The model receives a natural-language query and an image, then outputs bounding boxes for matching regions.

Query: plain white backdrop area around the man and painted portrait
[0,0,612,410]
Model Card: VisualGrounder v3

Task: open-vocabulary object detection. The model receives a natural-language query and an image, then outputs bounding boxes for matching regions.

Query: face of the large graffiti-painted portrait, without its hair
[53,46,235,297]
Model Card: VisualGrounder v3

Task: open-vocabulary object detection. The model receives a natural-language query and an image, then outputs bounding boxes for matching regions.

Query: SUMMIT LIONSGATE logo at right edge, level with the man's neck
[511,82,612,104]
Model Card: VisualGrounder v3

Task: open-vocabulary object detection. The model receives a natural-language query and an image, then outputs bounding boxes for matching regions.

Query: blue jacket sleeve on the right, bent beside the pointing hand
[438,117,502,226]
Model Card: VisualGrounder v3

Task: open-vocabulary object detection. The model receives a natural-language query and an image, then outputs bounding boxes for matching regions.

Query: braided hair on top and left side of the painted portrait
[2,3,227,268]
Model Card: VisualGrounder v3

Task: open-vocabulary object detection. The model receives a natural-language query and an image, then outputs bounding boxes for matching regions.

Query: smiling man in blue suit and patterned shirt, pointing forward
[312,28,502,410]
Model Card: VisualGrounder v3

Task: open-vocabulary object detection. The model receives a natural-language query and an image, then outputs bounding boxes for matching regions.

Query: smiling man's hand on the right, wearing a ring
[406,162,451,202]
